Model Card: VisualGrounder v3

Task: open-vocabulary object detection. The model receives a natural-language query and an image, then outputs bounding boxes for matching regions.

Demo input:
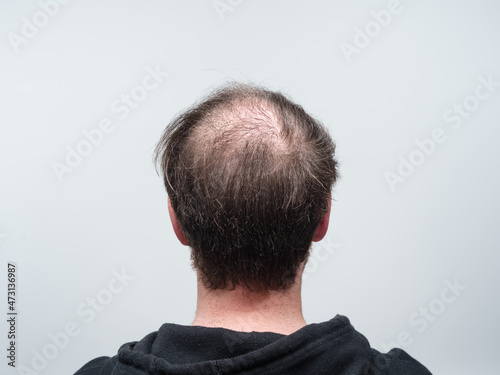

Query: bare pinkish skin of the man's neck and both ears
[168,199,331,335]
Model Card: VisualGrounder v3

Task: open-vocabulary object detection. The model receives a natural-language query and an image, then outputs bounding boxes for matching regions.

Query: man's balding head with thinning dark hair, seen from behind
[155,84,337,292]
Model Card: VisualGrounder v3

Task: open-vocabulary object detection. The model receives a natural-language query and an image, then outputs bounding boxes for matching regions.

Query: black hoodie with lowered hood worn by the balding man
[75,315,431,375]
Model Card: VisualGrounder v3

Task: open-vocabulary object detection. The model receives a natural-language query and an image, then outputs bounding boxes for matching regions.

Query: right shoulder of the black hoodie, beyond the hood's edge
[365,349,432,375]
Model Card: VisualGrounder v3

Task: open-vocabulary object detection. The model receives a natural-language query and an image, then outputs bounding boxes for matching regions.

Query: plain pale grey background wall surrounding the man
[0,0,500,375]
